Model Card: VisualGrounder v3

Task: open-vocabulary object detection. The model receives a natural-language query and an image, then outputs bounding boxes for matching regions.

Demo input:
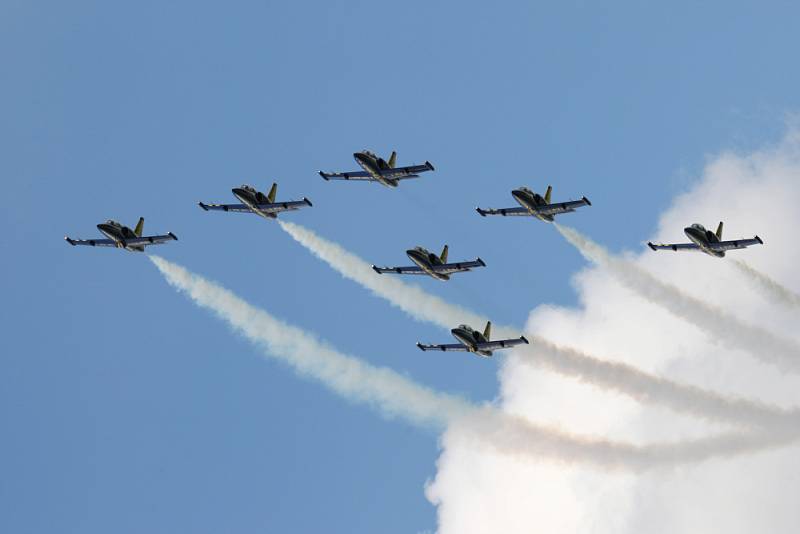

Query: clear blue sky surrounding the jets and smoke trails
[0,0,800,533]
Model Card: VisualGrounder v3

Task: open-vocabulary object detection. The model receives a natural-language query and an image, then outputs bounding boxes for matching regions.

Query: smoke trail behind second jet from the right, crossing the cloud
[555,224,800,373]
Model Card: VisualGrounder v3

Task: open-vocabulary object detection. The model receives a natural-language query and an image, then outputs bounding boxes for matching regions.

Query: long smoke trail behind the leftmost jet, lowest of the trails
[150,256,791,471]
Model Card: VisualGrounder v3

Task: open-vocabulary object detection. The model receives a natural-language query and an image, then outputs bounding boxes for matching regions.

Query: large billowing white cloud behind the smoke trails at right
[427,127,800,534]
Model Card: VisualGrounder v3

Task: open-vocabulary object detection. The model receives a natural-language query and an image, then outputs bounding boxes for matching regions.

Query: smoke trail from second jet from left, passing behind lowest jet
[280,222,800,429]
